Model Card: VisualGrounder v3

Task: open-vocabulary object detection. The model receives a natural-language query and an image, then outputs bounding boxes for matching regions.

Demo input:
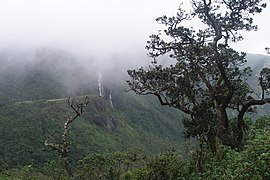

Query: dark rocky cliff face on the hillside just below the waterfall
[84,97,117,132]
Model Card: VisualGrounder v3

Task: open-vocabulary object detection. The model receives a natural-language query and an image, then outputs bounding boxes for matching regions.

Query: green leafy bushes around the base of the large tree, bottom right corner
[187,117,270,179]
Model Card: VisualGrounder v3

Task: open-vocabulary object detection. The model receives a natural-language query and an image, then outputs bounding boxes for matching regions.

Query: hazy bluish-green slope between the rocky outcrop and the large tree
[113,90,184,141]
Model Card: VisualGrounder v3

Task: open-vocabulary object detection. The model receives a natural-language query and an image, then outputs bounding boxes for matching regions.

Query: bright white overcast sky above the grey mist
[0,0,270,56]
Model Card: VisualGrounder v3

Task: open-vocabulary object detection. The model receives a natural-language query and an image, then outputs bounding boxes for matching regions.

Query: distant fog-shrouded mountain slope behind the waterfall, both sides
[0,48,270,101]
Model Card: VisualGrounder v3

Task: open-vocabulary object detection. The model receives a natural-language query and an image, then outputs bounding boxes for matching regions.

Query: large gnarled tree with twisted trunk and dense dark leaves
[128,0,269,154]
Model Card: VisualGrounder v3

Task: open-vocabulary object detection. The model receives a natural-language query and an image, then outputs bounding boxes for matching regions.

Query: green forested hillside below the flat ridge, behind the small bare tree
[0,96,186,167]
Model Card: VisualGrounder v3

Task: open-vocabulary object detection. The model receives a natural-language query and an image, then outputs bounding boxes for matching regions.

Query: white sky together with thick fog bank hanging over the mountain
[0,0,270,91]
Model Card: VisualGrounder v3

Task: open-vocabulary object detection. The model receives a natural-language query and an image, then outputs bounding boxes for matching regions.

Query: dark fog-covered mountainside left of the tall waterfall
[0,49,94,101]
